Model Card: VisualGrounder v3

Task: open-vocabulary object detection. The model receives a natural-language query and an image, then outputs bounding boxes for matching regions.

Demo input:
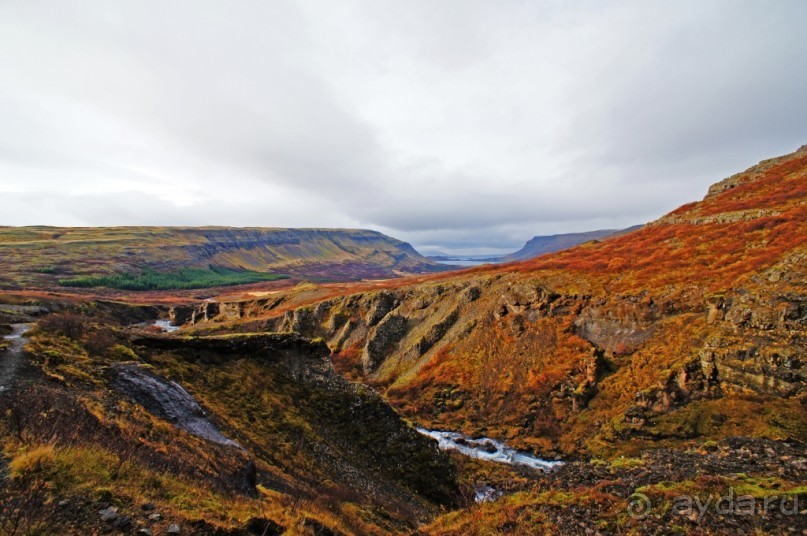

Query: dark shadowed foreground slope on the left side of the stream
[0,313,458,535]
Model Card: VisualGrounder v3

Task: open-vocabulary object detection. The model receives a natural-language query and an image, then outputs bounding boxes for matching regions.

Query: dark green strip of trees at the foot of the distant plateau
[59,266,289,290]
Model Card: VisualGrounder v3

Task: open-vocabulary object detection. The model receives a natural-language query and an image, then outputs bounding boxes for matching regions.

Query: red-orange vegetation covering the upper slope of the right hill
[506,150,807,290]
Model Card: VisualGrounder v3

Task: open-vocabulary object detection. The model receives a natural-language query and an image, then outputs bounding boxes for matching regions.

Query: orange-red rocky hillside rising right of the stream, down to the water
[188,144,807,454]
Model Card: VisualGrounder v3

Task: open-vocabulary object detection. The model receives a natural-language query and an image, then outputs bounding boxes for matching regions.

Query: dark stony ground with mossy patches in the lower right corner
[421,437,807,535]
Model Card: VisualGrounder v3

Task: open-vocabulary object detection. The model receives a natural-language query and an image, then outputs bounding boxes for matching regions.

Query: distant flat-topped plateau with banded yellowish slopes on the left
[0,227,441,290]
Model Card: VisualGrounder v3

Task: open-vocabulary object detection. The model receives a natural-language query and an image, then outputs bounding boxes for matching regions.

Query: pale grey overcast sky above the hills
[0,0,807,253]
